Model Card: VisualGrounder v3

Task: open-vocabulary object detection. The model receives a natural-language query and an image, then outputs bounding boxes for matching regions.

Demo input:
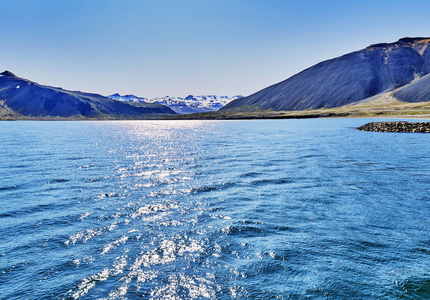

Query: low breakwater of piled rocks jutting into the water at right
[357,121,430,133]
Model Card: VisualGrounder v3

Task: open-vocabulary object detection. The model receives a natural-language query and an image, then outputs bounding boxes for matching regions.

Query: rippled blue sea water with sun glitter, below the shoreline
[0,119,430,299]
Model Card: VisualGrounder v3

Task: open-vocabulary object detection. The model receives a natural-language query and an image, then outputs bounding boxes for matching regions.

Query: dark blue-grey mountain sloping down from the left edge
[0,71,175,118]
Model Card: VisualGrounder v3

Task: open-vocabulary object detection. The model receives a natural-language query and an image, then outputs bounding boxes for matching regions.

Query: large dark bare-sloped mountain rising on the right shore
[222,38,430,111]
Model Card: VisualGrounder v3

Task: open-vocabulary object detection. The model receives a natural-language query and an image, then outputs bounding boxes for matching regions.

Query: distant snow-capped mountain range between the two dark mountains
[108,94,243,114]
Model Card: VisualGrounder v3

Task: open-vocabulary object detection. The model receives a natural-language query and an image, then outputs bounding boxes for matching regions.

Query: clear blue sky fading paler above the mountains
[0,0,430,98]
